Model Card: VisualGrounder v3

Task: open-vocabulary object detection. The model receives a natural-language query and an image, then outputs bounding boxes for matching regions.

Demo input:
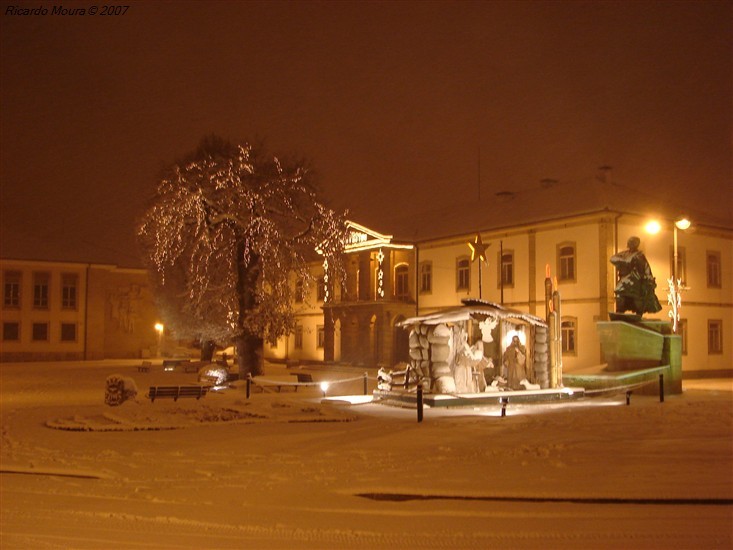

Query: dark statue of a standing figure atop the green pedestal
[611,237,662,317]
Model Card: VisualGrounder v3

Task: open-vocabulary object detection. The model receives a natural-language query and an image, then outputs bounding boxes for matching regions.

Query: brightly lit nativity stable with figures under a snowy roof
[379,300,562,394]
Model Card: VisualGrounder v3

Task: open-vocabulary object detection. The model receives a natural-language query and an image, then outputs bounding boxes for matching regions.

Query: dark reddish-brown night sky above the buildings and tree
[0,0,733,265]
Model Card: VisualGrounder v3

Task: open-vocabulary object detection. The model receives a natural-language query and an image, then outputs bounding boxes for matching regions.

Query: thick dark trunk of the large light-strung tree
[235,240,263,379]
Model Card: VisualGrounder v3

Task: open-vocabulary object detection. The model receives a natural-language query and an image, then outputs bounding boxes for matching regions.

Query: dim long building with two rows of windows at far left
[0,259,162,362]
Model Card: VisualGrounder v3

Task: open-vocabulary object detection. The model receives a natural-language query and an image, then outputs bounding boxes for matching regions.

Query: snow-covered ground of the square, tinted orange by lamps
[0,361,733,550]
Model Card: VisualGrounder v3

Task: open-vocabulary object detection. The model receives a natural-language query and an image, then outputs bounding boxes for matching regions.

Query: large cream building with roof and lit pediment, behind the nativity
[265,178,733,377]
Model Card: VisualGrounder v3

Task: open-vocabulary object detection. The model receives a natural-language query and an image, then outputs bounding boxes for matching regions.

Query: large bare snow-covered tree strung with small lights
[138,137,346,374]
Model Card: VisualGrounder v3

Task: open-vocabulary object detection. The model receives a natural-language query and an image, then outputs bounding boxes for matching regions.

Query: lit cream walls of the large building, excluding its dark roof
[265,209,733,377]
